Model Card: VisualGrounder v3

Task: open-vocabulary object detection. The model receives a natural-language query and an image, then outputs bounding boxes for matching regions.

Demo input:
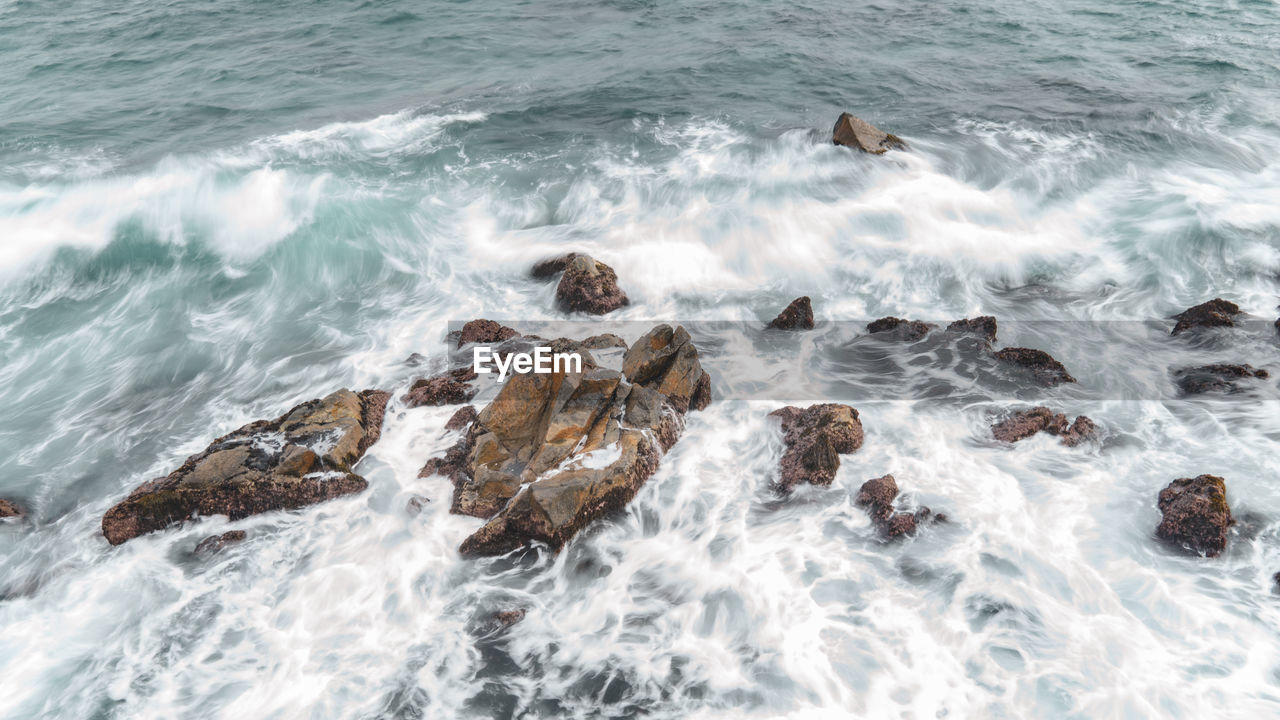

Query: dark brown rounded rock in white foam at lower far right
[1156,475,1235,557]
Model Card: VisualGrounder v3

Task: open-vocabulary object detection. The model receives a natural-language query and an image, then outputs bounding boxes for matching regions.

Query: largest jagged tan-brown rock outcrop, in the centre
[422,325,710,556]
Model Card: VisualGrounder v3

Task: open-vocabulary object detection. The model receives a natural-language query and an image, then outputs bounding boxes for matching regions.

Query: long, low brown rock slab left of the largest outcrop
[102,389,390,544]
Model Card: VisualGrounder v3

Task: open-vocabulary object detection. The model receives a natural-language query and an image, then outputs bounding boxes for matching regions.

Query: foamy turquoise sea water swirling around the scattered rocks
[0,0,1280,719]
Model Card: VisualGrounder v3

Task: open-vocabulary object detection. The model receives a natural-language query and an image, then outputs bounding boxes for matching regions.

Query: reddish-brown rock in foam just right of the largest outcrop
[769,402,863,492]
